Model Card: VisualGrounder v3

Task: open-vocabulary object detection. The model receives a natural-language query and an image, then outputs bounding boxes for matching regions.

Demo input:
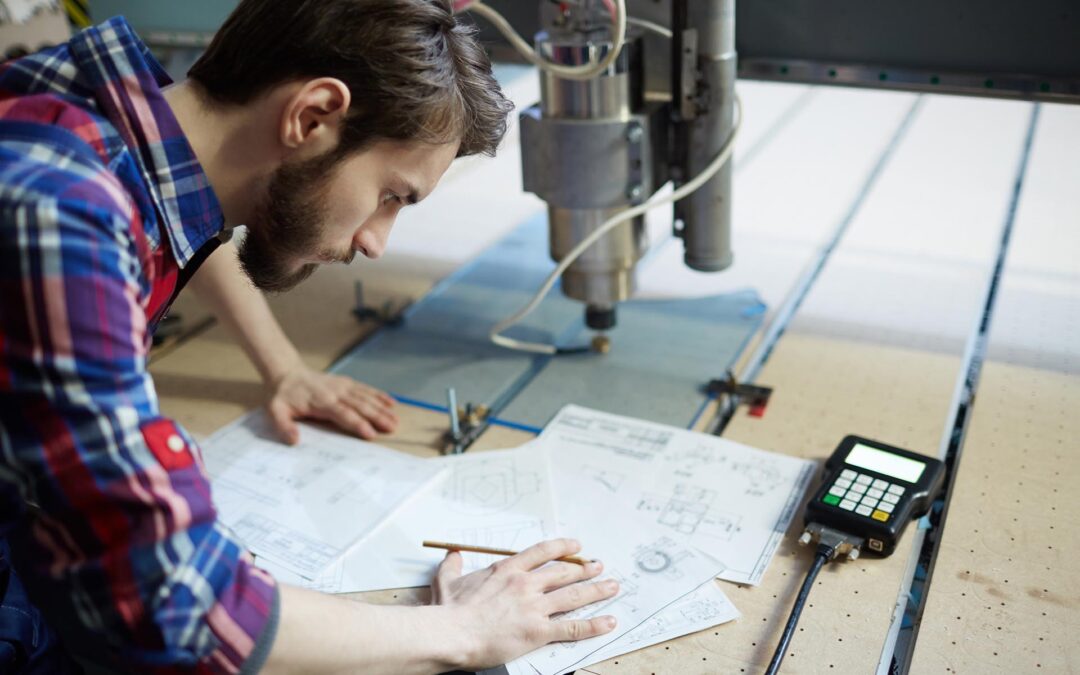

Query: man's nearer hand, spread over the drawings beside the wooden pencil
[432,539,619,669]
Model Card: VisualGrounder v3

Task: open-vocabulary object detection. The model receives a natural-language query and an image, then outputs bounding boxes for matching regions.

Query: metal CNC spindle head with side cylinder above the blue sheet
[511,0,735,330]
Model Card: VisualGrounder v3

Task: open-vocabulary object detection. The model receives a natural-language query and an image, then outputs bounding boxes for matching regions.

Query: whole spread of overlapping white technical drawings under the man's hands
[204,406,813,675]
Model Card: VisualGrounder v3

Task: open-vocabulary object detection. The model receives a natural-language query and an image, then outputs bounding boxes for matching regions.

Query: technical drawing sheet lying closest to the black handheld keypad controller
[544,406,814,584]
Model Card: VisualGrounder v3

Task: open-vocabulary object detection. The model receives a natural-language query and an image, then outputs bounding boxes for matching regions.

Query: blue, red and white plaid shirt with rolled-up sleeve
[0,18,279,673]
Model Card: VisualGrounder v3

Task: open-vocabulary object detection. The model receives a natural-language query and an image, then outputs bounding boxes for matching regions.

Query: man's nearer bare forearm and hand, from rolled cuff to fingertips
[262,539,619,675]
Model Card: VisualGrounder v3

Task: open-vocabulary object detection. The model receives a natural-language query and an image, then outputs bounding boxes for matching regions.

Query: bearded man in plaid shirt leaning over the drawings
[0,0,617,674]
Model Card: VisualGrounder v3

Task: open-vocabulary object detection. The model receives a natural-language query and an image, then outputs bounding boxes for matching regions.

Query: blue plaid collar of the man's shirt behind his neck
[70,17,225,268]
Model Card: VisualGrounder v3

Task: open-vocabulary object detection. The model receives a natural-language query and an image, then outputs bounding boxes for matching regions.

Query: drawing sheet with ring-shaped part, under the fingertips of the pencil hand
[507,531,726,675]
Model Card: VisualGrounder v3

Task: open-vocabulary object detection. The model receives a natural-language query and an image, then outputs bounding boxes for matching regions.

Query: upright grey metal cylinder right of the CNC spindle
[675,0,737,272]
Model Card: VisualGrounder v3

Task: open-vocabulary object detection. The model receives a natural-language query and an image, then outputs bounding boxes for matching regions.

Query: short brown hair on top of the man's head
[188,0,512,158]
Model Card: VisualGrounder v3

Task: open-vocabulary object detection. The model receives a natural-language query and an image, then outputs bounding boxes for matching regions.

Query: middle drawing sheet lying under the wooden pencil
[259,445,556,593]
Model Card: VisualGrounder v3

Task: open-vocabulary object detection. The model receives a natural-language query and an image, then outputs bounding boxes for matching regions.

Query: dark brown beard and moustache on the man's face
[239,152,355,293]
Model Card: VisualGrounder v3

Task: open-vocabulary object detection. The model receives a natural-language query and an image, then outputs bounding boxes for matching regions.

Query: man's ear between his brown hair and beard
[280,78,352,159]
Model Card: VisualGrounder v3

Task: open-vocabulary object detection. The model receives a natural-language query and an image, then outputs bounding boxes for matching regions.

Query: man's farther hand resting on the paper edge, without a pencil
[267,365,397,445]
